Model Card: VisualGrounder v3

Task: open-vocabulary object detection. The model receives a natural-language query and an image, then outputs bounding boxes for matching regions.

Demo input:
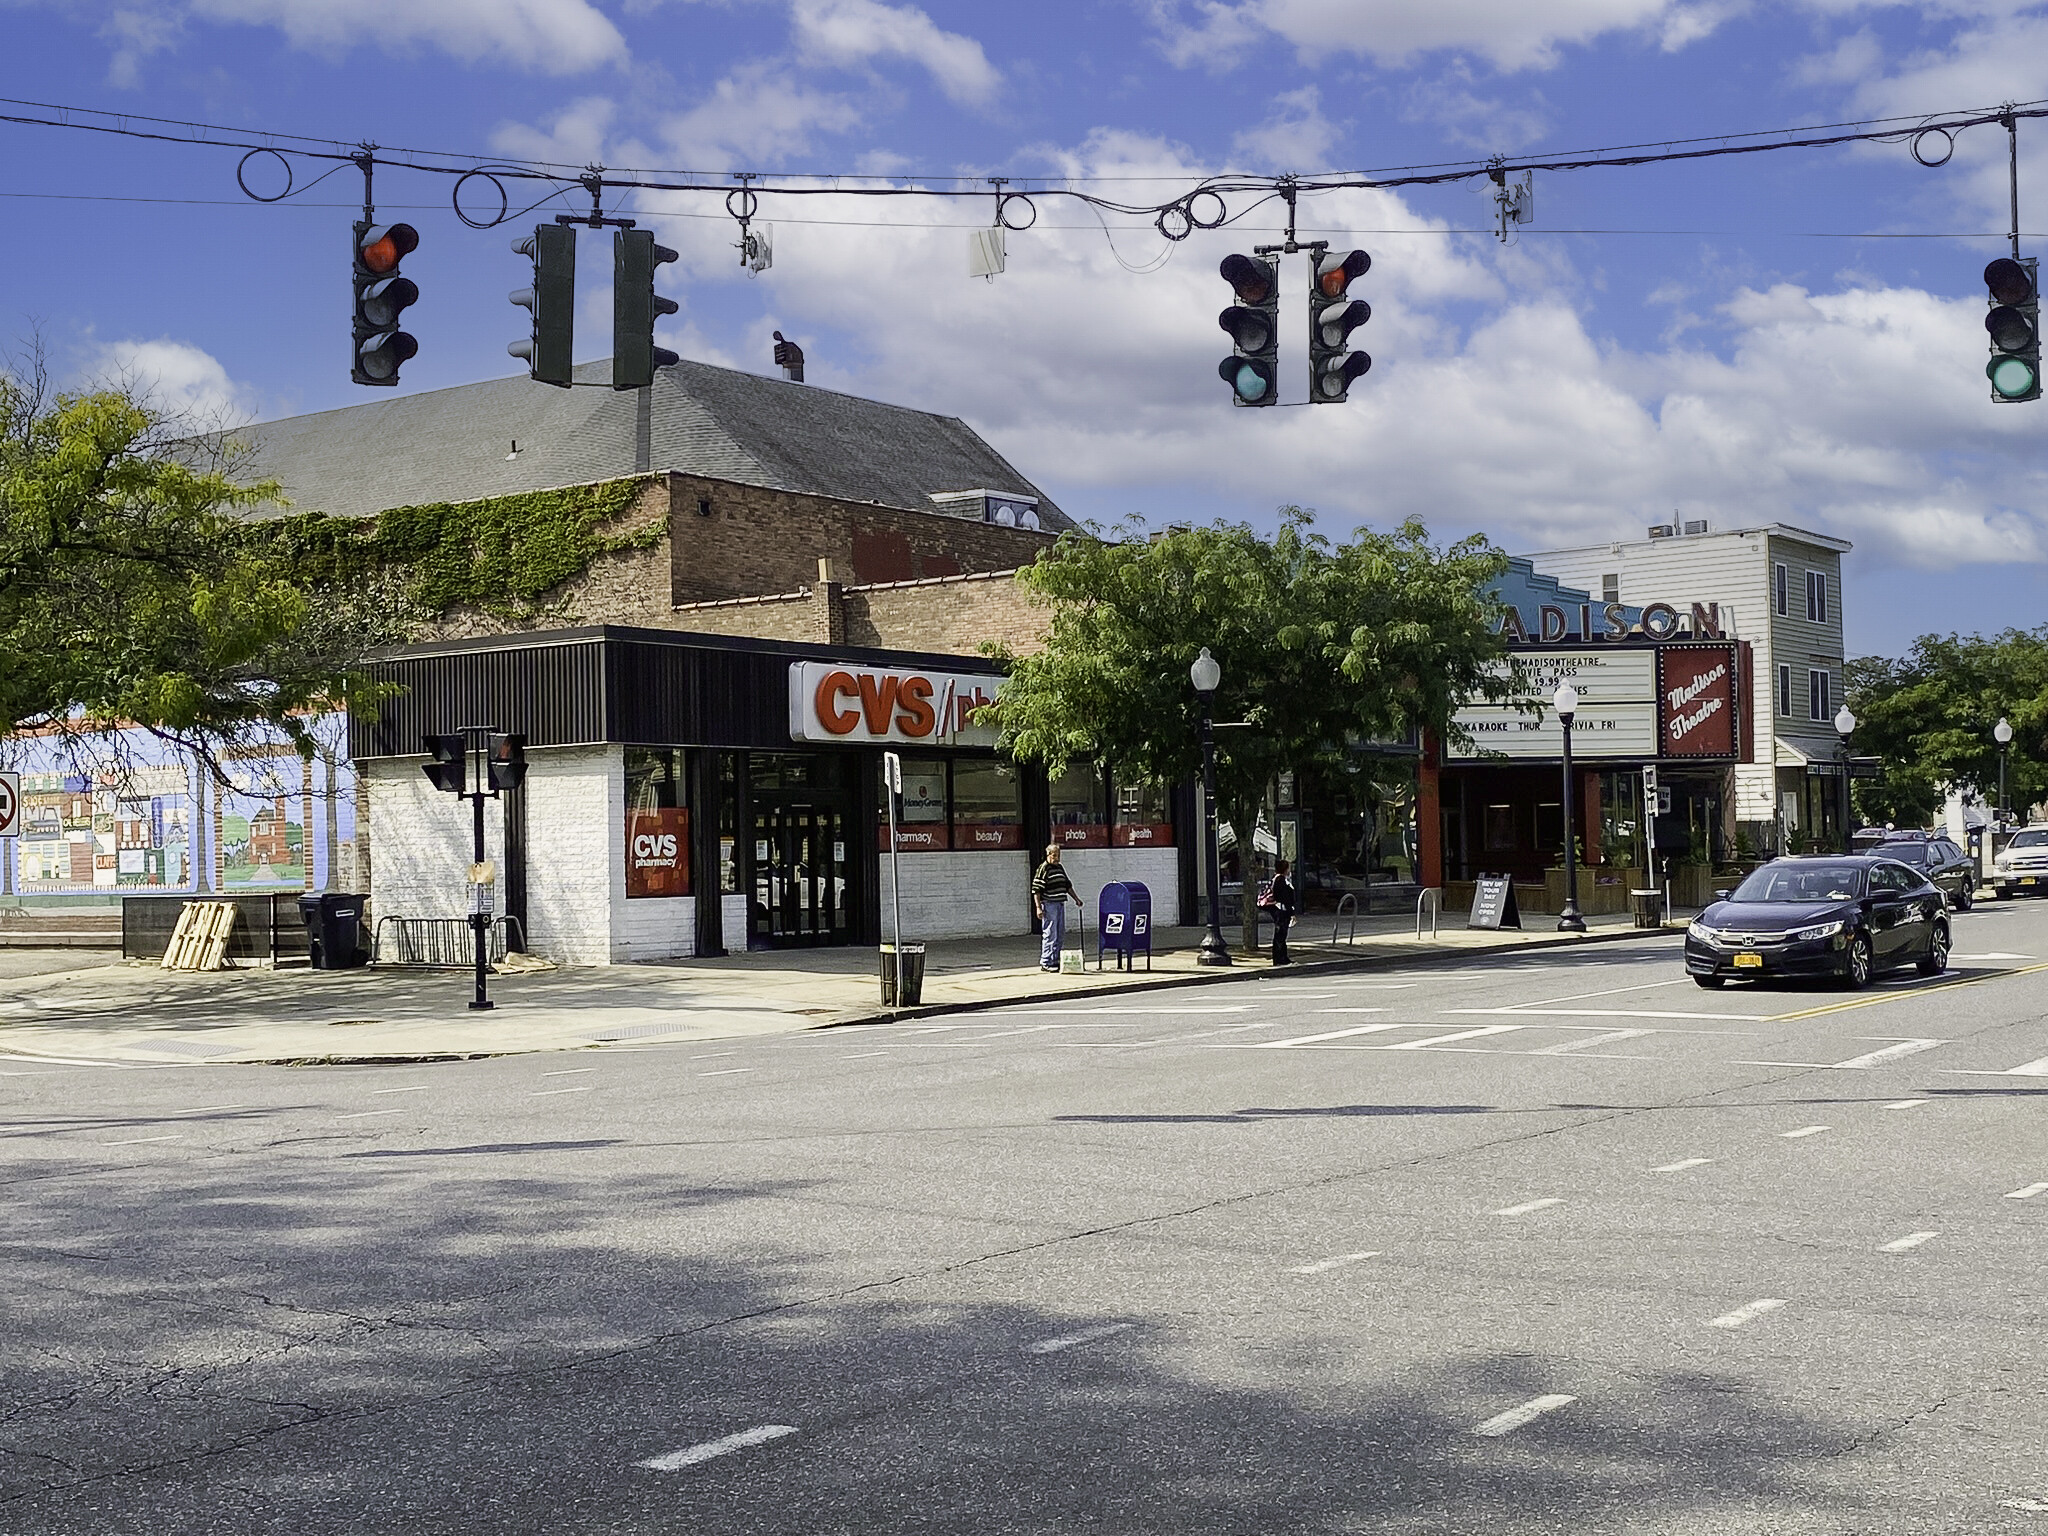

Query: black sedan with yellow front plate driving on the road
[1686,854,1948,987]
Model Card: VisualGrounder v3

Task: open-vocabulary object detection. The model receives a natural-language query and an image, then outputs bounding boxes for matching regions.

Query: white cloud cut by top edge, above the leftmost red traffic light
[188,0,627,74]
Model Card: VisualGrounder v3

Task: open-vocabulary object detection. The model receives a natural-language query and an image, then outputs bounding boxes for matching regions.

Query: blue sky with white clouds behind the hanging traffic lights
[0,0,2048,655]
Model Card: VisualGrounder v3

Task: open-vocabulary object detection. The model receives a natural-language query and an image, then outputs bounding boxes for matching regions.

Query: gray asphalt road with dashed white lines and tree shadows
[0,903,2048,1536]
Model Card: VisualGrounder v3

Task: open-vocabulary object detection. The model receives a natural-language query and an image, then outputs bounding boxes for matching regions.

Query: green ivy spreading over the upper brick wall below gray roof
[250,475,668,625]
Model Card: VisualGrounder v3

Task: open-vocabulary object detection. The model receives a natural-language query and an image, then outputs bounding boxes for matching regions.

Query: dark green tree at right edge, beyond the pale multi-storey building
[1843,625,2048,825]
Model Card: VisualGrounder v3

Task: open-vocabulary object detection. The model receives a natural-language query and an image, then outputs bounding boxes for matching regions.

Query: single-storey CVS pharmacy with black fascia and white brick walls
[352,627,1194,965]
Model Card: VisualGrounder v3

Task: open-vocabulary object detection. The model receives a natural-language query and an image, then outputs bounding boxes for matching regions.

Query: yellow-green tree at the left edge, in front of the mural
[0,356,387,760]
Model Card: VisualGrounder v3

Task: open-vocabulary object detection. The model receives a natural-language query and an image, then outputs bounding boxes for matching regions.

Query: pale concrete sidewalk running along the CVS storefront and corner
[0,918,1649,1073]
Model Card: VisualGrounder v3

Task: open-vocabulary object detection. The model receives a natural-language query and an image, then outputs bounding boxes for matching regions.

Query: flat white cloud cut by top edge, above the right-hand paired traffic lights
[1151,0,1741,70]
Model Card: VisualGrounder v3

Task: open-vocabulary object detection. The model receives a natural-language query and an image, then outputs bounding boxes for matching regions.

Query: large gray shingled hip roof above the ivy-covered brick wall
[233,360,1075,530]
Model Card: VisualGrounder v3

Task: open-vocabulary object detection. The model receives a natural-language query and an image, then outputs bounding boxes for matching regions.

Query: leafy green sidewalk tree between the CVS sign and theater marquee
[987,506,1505,948]
